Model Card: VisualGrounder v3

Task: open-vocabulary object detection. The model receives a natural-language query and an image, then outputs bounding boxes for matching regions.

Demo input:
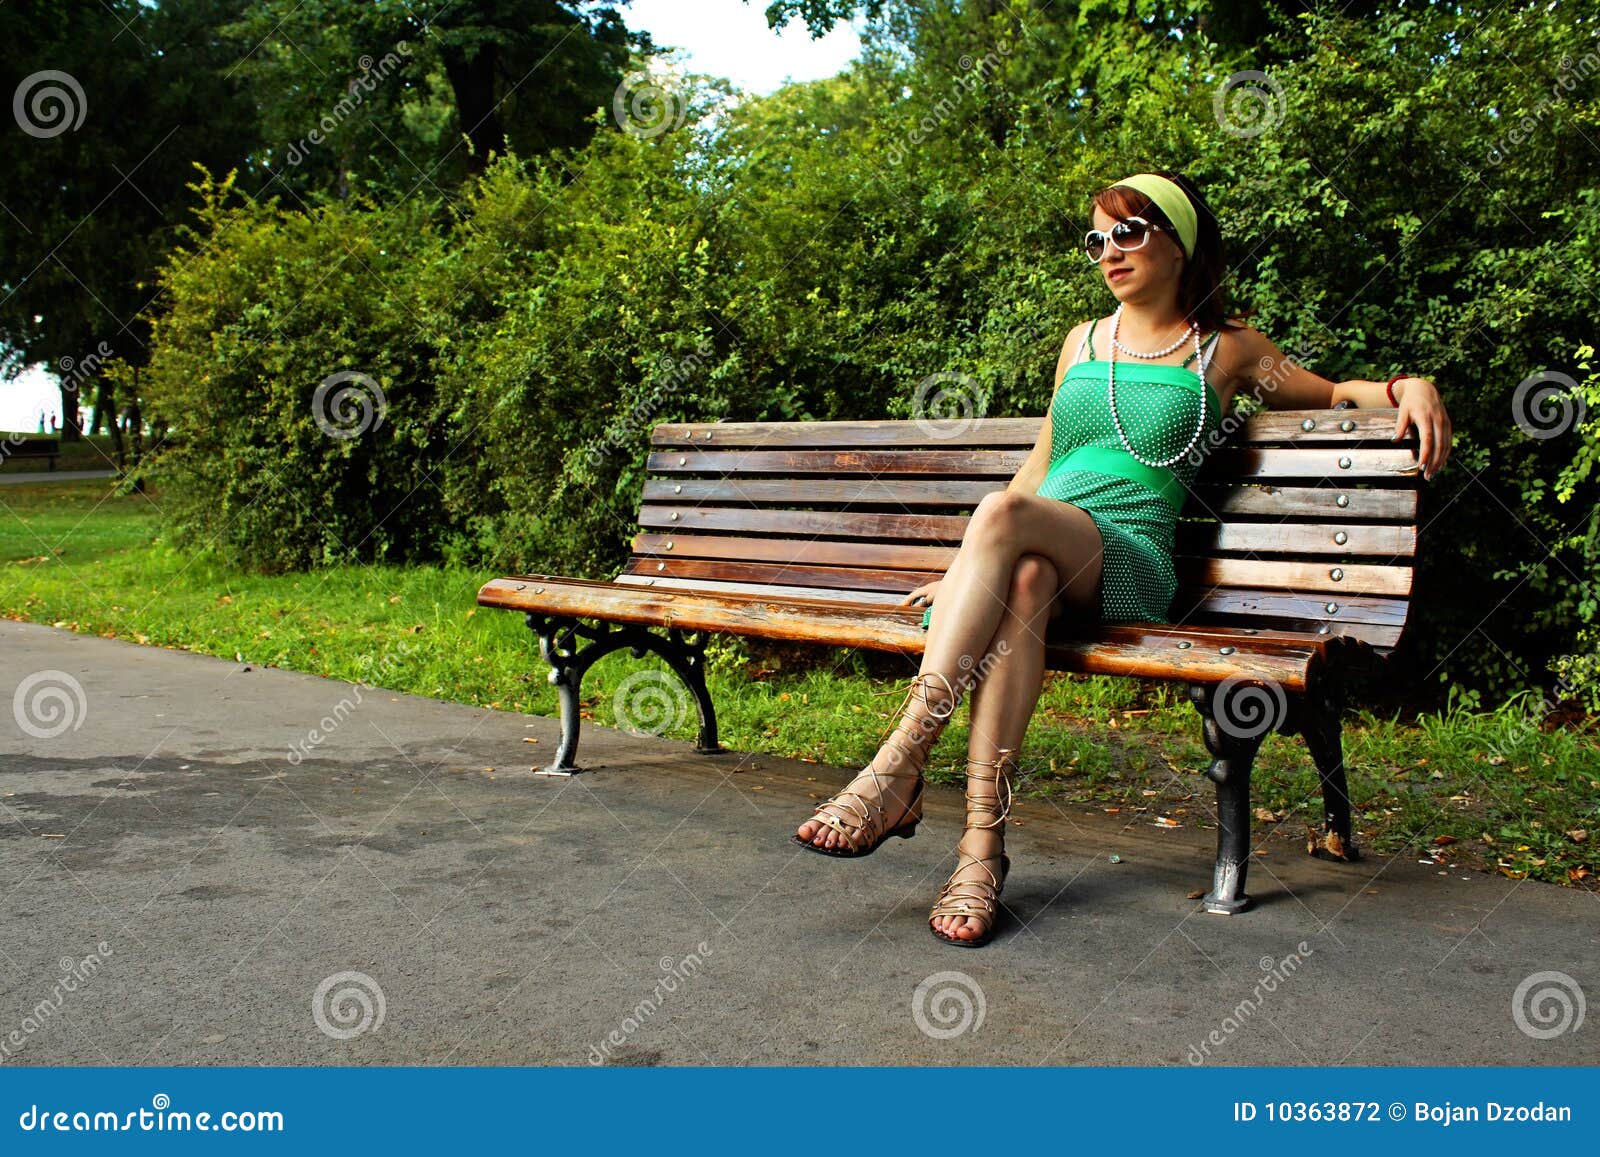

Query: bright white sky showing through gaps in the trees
[0,0,861,432]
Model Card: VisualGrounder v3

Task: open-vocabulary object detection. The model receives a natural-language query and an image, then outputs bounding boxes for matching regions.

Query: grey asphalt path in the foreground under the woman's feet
[0,623,1600,1064]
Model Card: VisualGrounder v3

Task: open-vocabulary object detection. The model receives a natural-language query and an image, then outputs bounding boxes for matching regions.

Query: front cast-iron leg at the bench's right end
[1189,682,1288,915]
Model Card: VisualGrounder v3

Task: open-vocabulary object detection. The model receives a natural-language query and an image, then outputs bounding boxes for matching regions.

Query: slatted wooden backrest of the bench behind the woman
[618,410,1418,653]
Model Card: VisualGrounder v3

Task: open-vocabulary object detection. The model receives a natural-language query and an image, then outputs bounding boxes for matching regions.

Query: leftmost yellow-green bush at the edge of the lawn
[122,176,451,571]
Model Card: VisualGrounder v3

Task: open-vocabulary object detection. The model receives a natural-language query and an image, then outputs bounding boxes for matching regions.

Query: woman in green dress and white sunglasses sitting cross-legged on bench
[794,171,1451,947]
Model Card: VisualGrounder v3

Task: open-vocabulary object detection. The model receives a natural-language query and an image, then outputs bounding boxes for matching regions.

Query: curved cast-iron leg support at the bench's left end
[525,611,728,776]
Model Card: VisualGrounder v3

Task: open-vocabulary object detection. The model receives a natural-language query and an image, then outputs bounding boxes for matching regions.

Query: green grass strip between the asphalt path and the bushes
[9,480,1600,888]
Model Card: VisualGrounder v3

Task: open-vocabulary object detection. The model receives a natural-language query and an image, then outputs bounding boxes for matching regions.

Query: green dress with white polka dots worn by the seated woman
[922,316,1222,629]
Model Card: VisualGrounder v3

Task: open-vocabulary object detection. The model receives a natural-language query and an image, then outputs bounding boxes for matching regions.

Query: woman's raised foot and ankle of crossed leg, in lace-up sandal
[795,671,955,855]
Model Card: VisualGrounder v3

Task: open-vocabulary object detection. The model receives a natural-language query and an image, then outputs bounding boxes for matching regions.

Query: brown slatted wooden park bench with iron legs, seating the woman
[478,403,1419,912]
